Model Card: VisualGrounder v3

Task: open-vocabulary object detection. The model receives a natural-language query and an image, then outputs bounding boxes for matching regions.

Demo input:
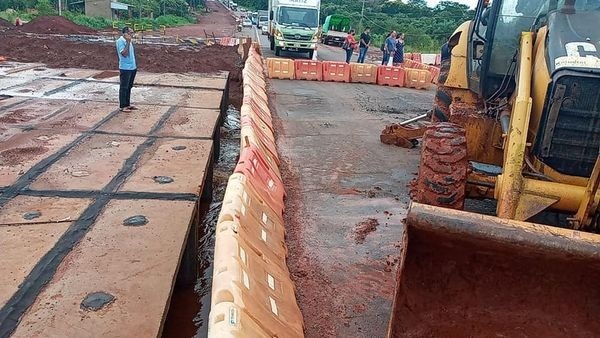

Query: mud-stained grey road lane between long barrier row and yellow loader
[270,76,433,337]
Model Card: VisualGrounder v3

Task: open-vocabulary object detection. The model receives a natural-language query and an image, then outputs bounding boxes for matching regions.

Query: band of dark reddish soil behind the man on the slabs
[0,30,243,107]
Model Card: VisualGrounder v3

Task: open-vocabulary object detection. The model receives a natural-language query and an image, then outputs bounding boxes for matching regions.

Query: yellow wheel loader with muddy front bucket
[388,0,600,337]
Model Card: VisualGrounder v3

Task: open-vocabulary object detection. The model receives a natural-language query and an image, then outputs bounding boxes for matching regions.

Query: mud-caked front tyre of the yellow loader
[410,122,469,210]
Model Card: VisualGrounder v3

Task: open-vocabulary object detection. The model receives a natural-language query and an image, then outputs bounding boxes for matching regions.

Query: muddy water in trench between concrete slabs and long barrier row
[163,107,240,338]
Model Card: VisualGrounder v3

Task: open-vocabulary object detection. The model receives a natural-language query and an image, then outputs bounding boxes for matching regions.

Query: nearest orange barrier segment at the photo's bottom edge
[209,231,304,338]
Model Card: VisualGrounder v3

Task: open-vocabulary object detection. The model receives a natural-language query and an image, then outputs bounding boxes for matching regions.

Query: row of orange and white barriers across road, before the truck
[267,58,440,89]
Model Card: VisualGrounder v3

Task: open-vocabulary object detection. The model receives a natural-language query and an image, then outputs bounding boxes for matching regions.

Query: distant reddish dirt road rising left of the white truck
[167,1,236,38]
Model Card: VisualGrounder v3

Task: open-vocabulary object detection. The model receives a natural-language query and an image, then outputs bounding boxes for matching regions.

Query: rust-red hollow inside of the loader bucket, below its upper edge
[392,230,600,337]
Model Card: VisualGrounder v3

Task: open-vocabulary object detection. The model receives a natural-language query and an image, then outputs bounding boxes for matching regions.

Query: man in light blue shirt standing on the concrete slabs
[116,27,137,111]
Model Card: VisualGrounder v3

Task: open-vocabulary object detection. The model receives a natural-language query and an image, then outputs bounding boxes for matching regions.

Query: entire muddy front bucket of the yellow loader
[388,203,600,337]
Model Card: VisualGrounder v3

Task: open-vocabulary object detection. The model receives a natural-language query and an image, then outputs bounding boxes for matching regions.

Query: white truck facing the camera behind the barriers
[268,0,321,59]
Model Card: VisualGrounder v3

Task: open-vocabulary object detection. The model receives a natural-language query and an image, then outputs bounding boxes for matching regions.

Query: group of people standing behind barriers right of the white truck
[342,27,404,66]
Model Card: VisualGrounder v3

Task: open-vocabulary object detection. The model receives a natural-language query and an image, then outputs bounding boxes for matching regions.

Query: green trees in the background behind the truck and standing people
[237,0,475,52]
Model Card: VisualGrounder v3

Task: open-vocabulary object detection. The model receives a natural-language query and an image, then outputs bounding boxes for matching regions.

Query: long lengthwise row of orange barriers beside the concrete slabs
[208,48,304,338]
